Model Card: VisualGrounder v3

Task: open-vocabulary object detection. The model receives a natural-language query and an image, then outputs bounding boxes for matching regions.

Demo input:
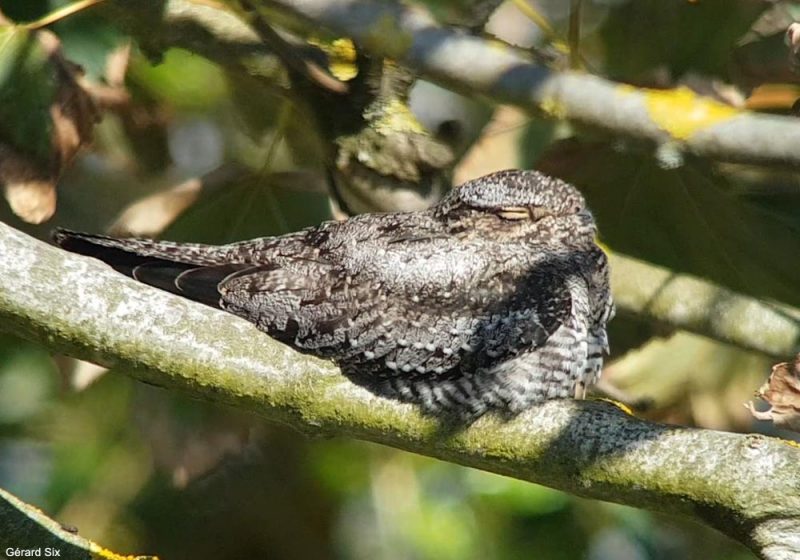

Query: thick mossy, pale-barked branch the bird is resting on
[0,224,800,559]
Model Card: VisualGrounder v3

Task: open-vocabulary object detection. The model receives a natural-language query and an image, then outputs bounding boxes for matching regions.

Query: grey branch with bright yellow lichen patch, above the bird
[262,0,800,167]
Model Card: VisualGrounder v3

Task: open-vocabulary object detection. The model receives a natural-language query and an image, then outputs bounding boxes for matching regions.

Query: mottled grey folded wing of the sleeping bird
[219,223,571,390]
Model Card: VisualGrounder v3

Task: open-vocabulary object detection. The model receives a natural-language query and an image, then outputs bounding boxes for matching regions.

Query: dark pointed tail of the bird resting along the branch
[52,228,247,307]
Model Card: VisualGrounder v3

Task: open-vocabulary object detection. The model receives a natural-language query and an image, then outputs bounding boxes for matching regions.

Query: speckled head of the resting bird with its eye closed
[433,170,595,240]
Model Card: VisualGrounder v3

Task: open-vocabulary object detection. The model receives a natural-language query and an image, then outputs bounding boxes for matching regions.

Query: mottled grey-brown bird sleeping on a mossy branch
[54,171,613,418]
